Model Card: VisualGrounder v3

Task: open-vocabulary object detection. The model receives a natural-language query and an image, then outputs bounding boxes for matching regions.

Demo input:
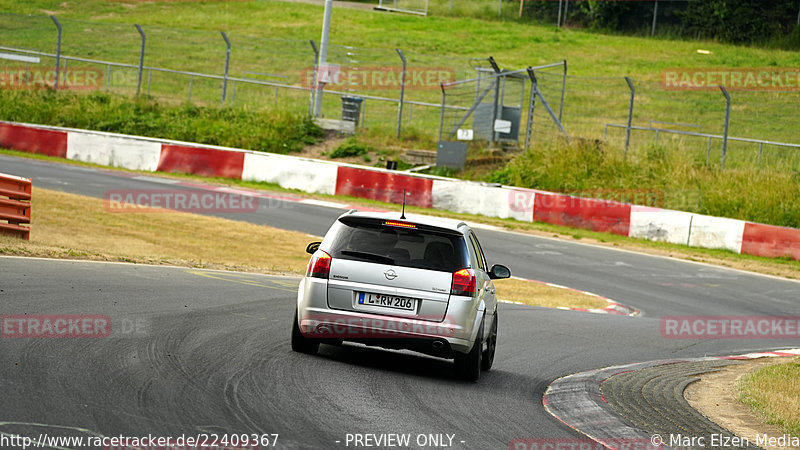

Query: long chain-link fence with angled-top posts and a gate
[0,14,800,170]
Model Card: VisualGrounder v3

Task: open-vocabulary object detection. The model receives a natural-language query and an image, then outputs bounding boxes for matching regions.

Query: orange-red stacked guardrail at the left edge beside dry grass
[0,173,32,240]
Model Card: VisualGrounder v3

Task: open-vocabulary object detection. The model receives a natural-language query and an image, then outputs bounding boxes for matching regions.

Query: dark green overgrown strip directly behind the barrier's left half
[0,90,324,153]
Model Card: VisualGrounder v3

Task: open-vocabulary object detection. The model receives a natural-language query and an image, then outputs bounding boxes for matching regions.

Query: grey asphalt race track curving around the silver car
[0,155,800,449]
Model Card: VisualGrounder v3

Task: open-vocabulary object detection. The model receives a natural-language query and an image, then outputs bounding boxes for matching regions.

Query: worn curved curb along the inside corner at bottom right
[542,348,800,448]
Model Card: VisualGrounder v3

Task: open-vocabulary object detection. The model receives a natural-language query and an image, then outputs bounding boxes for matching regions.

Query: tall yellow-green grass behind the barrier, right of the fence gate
[485,141,800,228]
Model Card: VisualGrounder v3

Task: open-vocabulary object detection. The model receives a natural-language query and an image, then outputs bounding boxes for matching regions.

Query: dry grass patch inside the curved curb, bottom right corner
[738,359,800,437]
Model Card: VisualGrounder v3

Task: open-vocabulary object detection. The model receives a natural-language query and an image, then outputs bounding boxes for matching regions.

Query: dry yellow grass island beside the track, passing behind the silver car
[0,187,605,308]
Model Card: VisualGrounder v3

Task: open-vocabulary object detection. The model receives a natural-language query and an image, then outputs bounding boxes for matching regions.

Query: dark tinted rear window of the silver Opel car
[326,220,469,272]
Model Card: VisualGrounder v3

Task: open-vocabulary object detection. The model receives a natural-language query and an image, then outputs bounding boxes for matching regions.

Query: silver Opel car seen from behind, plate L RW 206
[292,211,511,381]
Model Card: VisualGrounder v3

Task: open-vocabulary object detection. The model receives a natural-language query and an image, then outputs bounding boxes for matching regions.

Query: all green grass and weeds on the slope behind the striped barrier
[0,0,800,227]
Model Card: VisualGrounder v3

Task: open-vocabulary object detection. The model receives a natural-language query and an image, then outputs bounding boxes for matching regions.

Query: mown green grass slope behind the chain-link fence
[0,0,800,147]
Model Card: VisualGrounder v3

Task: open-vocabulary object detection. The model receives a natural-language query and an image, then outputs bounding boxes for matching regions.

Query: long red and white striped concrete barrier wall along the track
[0,122,800,260]
